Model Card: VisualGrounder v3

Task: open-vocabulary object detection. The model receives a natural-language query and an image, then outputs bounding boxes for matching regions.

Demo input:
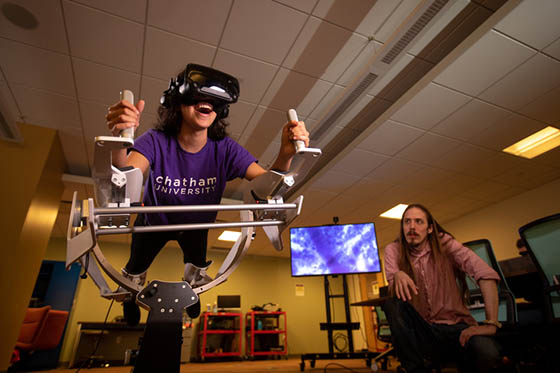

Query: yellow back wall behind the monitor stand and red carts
[46,232,365,362]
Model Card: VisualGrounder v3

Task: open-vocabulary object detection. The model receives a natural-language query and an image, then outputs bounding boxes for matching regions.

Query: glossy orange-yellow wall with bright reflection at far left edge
[0,124,65,370]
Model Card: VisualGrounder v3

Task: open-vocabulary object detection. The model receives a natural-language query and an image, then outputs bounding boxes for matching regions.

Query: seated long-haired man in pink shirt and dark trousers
[383,204,501,373]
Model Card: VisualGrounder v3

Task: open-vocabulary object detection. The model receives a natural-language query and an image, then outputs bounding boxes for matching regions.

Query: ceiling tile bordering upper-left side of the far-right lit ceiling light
[469,114,545,151]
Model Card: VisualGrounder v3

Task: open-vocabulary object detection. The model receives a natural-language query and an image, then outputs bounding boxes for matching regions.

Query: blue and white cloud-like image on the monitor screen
[290,223,381,277]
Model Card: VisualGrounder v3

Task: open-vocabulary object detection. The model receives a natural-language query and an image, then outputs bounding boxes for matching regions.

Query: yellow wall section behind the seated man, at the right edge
[445,179,560,260]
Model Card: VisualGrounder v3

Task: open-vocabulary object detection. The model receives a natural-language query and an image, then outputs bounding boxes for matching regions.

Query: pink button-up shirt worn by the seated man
[385,234,500,325]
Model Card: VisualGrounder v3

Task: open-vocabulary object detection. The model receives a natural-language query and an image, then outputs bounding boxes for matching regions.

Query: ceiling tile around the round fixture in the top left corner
[0,0,68,54]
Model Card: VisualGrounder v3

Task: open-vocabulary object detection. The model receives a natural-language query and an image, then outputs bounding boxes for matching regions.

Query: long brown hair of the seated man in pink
[397,203,469,304]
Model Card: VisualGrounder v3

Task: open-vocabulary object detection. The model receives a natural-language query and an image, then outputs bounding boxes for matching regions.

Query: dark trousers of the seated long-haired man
[383,298,501,373]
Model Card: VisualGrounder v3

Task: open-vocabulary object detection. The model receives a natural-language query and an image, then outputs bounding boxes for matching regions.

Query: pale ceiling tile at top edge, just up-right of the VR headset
[220,0,307,65]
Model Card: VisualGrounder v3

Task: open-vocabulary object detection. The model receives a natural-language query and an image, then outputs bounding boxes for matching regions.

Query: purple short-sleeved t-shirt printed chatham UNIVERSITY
[132,129,256,225]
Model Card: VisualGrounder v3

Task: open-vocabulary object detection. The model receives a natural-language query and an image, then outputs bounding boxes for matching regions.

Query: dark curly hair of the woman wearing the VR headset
[155,69,229,141]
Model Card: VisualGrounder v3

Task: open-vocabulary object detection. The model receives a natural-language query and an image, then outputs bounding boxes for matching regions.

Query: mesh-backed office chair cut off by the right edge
[519,214,560,325]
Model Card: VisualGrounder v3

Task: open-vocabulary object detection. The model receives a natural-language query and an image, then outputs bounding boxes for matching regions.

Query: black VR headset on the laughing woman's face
[160,64,239,119]
